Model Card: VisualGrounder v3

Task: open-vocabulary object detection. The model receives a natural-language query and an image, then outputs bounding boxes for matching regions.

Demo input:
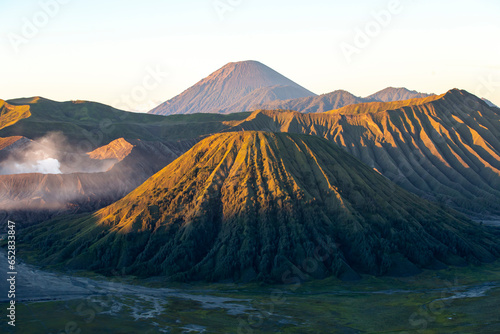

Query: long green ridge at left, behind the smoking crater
[0,97,248,150]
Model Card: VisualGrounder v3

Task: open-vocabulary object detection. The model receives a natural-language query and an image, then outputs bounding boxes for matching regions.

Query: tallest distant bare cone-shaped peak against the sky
[149,61,316,115]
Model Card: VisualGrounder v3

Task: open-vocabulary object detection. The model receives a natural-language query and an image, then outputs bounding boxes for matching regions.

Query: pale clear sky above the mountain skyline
[0,0,500,111]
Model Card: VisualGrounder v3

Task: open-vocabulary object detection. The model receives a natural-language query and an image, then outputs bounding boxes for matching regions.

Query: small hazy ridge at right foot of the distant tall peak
[252,90,373,114]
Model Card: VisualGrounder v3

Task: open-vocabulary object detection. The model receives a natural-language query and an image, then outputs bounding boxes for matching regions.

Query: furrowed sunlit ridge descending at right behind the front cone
[232,90,500,216]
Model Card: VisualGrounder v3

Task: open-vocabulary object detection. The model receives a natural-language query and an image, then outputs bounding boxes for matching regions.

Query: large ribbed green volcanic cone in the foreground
[22,132,500,283]
